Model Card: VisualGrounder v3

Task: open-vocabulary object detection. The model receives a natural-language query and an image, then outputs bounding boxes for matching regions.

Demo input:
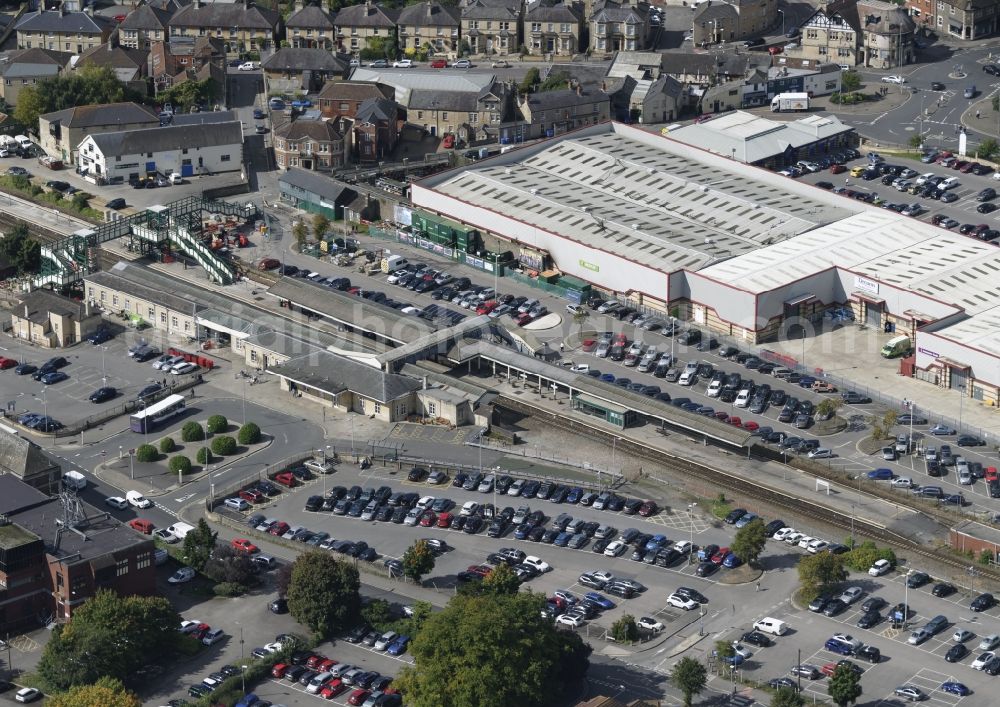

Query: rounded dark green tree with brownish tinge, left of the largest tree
[287,550,361,637]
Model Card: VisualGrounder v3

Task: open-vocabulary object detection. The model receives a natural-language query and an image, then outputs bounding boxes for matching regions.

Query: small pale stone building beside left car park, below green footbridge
[10,290,101,349]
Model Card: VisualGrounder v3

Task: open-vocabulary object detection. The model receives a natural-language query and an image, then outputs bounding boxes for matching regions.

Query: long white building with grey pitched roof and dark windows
[77,121,243,181]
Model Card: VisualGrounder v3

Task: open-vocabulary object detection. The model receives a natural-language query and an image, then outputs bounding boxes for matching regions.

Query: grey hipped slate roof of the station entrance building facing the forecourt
[267,351,421,403]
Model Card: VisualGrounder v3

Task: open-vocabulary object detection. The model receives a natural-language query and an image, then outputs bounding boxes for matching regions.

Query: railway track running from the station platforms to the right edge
[497,395,1000,581]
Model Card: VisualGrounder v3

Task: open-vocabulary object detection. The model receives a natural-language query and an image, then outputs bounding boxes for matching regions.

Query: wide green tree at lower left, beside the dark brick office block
[38,589,181,692]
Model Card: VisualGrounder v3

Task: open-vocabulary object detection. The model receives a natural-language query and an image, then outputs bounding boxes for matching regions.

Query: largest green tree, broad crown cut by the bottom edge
[395,592,590,707]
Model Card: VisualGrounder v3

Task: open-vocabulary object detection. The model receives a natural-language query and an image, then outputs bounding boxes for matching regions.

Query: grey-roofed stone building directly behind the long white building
[38,102,160,165]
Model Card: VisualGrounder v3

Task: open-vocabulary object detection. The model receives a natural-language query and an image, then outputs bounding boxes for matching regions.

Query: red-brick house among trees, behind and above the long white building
[149,37,228,100]
